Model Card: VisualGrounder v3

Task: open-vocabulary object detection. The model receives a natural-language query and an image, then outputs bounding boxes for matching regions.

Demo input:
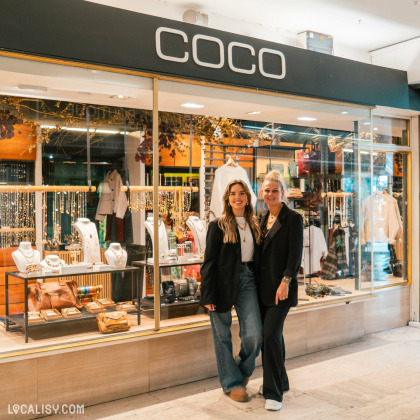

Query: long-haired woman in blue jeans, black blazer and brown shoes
[200,180,262,402]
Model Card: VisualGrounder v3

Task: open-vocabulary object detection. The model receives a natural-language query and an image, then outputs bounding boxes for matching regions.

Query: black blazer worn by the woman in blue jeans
[200,219,255,312]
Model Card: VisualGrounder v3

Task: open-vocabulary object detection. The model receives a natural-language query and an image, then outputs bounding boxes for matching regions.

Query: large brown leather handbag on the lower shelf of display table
[28,280,83,312]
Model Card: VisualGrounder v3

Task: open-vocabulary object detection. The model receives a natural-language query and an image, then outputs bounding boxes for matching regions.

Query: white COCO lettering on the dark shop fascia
[155,26,286,79]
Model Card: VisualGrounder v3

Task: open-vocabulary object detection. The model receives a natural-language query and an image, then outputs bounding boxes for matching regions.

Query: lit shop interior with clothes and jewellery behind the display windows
[0,58,410,353]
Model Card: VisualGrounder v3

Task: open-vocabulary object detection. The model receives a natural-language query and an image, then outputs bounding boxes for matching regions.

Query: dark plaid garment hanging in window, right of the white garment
[321,226,349,280]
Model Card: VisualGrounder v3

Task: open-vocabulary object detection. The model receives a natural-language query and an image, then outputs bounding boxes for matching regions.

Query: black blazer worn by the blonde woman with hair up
[255,203,303,307]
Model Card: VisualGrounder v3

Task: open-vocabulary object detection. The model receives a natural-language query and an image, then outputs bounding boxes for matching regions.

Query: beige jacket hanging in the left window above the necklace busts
[95,170,128,221]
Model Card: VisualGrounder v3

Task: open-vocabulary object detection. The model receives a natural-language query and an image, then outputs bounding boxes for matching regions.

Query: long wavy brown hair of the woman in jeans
[219,179,261,244]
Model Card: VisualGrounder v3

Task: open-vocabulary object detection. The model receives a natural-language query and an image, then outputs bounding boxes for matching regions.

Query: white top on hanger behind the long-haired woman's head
[210,164,257,220]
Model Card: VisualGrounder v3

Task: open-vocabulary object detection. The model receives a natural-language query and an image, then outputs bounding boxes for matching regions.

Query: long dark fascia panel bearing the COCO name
[0,0,409,108]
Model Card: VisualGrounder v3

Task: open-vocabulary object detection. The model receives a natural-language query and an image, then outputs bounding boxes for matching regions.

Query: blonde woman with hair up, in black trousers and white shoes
[257,171,303,411]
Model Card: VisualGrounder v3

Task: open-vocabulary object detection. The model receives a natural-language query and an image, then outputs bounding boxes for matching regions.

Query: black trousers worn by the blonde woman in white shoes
[261,306,290,402]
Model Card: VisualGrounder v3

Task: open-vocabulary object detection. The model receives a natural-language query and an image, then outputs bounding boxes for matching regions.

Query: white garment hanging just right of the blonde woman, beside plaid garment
[301,226,328,274]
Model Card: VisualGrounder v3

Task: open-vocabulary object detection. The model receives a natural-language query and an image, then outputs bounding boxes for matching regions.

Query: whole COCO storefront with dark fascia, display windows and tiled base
[0,0,420,414]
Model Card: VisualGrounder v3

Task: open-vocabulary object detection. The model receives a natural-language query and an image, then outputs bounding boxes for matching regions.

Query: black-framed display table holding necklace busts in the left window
[5,267,143,343]
